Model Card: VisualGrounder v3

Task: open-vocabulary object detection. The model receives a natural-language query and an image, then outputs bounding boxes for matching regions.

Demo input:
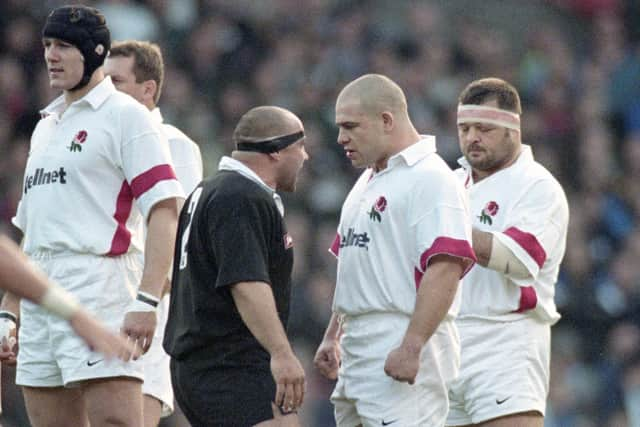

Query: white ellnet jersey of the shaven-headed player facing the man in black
[331,136,475,316]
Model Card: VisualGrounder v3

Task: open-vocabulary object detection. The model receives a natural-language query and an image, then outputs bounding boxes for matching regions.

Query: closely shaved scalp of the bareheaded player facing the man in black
[337,74,407,115]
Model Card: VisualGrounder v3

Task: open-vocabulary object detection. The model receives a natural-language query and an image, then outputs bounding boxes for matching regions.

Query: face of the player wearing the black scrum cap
[42,37,84,90]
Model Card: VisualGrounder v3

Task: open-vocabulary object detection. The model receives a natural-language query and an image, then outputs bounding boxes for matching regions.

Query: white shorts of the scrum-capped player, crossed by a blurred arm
[16,253,143,387]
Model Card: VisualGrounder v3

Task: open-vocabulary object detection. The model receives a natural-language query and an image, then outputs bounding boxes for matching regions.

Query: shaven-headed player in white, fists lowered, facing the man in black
[315,74,475,427]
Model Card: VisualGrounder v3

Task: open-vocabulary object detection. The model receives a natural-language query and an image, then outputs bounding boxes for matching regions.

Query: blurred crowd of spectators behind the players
[0,0,640,427]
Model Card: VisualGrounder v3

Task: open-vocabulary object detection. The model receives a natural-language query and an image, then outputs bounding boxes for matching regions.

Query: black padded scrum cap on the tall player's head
[42,5,111,90]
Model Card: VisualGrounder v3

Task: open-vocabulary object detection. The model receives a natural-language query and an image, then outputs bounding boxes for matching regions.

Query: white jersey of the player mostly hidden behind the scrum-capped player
[151,107,202,195]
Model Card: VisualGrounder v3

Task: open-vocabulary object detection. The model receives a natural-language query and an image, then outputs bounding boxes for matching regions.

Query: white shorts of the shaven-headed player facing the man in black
[331,313,459,427]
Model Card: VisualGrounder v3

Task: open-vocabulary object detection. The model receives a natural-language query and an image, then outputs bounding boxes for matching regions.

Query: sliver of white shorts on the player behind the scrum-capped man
[140,294,173,417]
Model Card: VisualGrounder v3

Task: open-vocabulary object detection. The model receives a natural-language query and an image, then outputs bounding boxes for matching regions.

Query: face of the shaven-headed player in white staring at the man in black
[336,97,388,169]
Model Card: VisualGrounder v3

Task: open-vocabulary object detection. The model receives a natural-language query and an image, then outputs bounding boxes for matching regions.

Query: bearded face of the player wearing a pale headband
[458,102,519,174]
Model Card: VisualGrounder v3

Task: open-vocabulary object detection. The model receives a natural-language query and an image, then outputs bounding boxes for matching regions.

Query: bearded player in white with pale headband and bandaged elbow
[447,78,569,427]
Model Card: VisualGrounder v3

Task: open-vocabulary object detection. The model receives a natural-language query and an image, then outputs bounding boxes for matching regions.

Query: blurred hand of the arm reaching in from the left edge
[69,310,142,362]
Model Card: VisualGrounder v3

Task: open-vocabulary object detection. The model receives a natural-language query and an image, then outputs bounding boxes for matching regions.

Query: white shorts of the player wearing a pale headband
[447,318,551,426]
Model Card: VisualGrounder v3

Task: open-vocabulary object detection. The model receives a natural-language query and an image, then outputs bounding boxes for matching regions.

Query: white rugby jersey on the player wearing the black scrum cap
[13,77,184,255]
